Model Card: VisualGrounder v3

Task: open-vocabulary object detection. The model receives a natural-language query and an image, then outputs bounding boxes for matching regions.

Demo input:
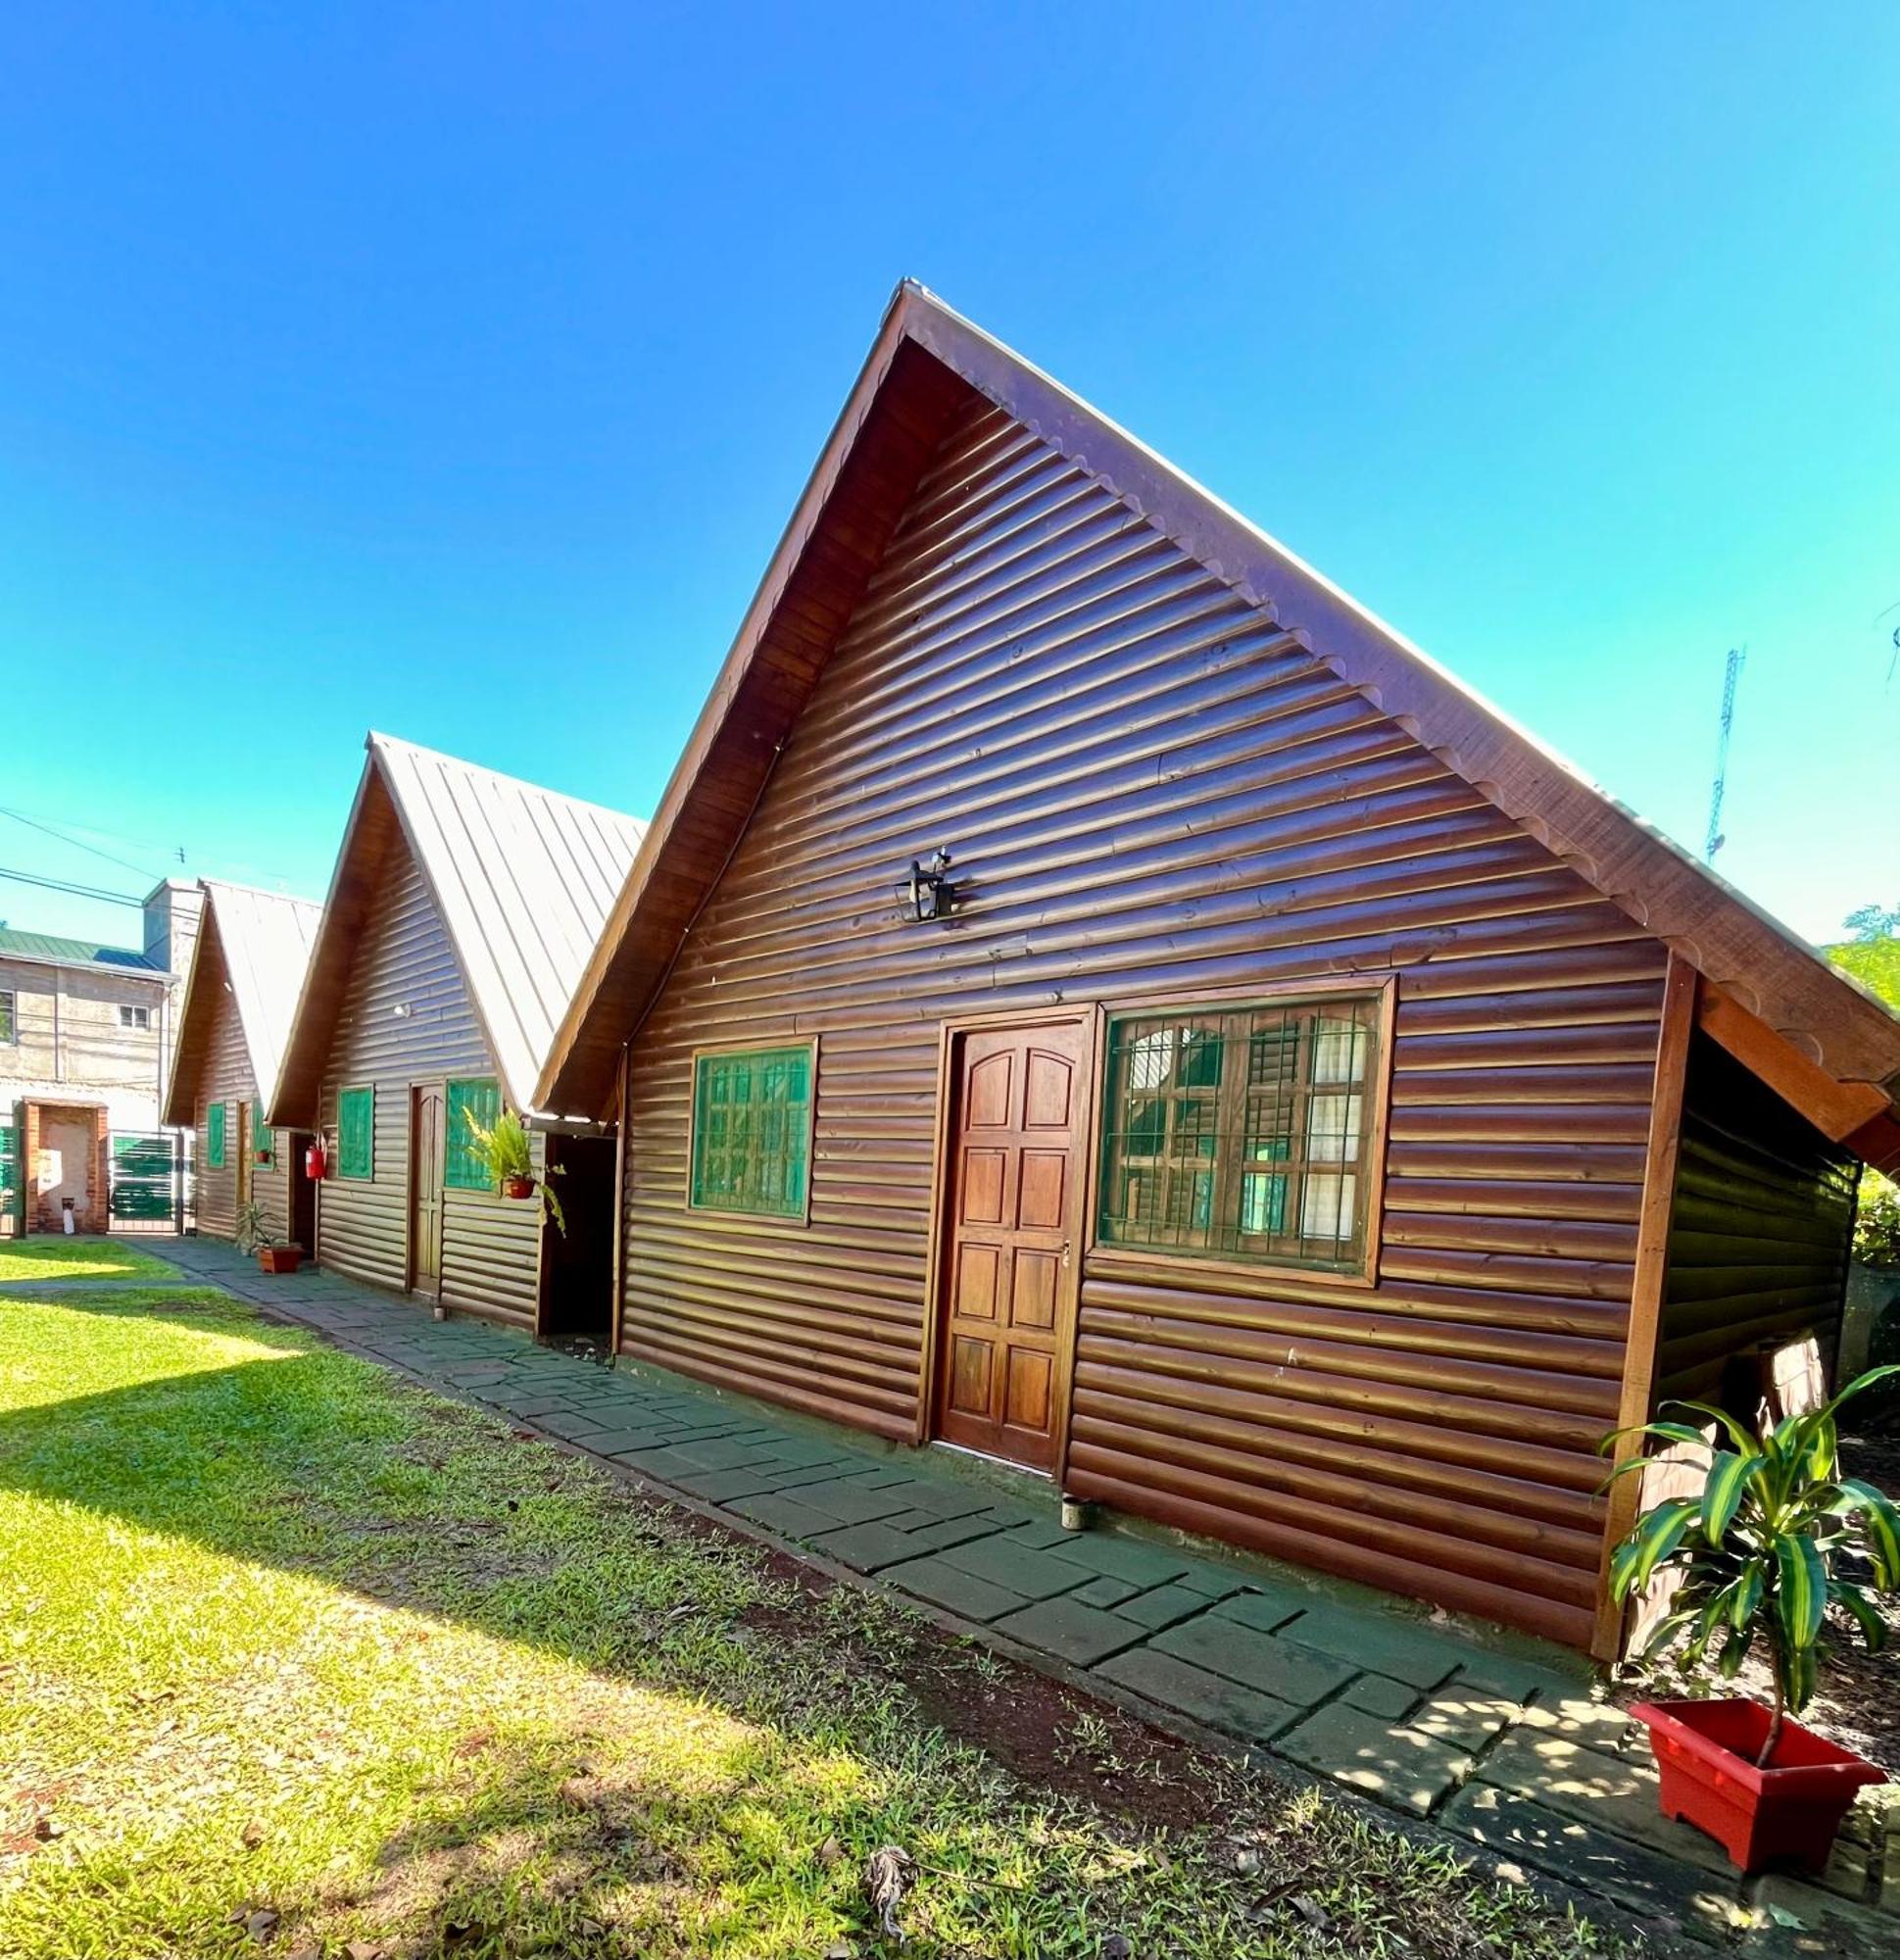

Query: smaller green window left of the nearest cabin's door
[688,1041,817,1219]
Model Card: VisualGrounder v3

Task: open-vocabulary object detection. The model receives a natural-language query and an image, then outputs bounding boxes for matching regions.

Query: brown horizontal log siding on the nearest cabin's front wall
[625,394,1665,1644]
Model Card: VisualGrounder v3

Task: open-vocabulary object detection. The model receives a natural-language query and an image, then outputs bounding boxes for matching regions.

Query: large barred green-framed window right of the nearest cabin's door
[1096,996,1381,1272]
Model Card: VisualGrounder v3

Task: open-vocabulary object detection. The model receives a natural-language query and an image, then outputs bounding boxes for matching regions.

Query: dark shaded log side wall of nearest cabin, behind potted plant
[1655,1033,1857,1415]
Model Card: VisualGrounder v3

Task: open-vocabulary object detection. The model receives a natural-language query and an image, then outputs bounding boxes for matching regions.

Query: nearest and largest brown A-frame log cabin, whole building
[537,284,1900,1654]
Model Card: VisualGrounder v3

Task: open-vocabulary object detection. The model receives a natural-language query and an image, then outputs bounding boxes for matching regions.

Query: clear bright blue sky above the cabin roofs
[0,0,1900,956]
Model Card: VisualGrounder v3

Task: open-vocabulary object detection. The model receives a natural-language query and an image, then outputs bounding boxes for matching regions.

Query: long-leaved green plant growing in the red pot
[1600,1362,1900,1764]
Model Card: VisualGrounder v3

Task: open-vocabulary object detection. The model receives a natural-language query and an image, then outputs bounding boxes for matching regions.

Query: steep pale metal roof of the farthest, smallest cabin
[163,878,323,1125]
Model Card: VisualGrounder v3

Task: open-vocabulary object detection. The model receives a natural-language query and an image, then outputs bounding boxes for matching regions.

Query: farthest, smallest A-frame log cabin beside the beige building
[163,878,323,1252]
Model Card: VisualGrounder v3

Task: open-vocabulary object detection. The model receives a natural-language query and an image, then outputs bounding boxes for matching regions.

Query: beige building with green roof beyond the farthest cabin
[0,878,198,1233]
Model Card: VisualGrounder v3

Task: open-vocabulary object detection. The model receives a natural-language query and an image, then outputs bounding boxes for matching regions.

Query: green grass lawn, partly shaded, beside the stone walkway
[0,1288,1608,1960]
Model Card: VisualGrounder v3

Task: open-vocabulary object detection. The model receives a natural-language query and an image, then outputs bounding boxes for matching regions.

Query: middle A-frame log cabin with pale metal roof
[270,733,645,1337]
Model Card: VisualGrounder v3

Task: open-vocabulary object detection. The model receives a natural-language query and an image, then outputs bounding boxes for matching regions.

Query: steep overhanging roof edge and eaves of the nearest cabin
[537,280,1900,1162]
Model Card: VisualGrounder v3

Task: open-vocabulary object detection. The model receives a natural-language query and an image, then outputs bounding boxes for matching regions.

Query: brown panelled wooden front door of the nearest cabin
[937,1021,1091,1470]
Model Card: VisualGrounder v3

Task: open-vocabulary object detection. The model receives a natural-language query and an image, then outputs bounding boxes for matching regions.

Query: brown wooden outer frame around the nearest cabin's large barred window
[1083,974,1398,1292]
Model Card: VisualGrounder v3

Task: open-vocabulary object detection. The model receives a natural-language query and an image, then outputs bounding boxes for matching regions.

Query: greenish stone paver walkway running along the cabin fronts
[59,1239,1900,1954]
